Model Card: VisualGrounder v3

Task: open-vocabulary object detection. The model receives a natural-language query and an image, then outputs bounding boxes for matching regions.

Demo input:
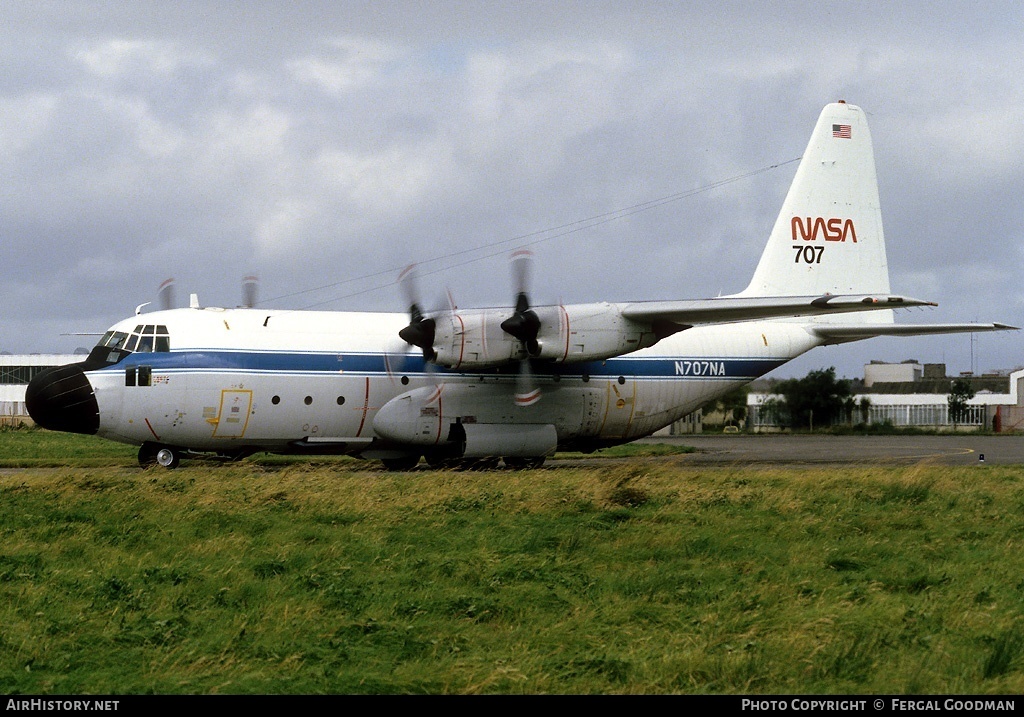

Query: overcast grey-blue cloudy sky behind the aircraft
[0,0,1024,377]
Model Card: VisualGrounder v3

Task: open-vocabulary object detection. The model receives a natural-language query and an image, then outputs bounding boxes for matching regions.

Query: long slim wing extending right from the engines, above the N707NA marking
[623,294,935,328]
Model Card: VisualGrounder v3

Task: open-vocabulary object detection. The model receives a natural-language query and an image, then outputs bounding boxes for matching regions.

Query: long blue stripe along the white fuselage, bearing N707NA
[98,350,787,380]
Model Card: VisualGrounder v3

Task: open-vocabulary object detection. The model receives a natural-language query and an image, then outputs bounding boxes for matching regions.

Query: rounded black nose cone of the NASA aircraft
[25,364,99,434]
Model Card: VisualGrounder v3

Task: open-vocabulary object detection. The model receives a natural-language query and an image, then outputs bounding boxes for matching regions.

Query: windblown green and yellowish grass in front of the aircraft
[0,431,1024,693]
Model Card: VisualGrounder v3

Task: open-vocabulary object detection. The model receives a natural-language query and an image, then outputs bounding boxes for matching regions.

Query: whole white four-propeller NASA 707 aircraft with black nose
[26,101,1014,469]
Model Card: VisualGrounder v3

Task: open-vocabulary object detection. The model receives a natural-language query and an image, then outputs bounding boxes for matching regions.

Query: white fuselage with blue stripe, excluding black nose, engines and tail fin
[86,308,820,453]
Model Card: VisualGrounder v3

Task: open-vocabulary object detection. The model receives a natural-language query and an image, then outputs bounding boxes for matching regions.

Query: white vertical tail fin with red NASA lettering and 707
[738,102,892,323]
